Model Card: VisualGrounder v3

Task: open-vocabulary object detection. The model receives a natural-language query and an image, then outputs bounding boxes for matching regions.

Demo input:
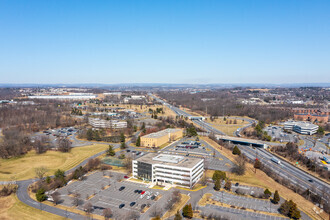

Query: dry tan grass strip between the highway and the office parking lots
[201,137,329,219]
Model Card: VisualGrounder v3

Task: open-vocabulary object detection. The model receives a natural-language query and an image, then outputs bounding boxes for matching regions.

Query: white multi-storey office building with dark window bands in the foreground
[132,153,204,188]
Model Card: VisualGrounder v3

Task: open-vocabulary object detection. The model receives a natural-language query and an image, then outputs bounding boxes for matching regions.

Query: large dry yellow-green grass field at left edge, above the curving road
[0,144,108,181]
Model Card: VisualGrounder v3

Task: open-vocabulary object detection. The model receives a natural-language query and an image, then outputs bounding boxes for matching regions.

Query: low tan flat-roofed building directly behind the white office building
[141,128,183,147]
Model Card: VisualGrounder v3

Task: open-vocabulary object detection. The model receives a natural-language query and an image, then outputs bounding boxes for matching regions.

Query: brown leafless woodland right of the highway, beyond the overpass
[158,89,293,123]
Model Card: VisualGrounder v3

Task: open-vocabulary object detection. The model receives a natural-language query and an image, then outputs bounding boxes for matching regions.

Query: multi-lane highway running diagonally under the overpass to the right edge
[151,95,330,202]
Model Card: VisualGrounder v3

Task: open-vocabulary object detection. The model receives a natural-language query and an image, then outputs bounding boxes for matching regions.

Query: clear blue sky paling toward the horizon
[0,0,330,84]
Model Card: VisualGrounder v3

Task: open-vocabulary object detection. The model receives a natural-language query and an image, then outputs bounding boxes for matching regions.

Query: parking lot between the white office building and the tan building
[162,138,233,171]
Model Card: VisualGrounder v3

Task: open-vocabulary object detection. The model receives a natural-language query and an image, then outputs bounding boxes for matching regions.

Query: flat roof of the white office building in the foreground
[136,153,203,168]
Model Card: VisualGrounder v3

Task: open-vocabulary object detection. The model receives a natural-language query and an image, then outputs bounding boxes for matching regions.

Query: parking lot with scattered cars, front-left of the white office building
[58,171,164,219]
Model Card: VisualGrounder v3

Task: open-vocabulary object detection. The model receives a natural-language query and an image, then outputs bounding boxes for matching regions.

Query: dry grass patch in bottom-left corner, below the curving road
[0,194,65,220]
